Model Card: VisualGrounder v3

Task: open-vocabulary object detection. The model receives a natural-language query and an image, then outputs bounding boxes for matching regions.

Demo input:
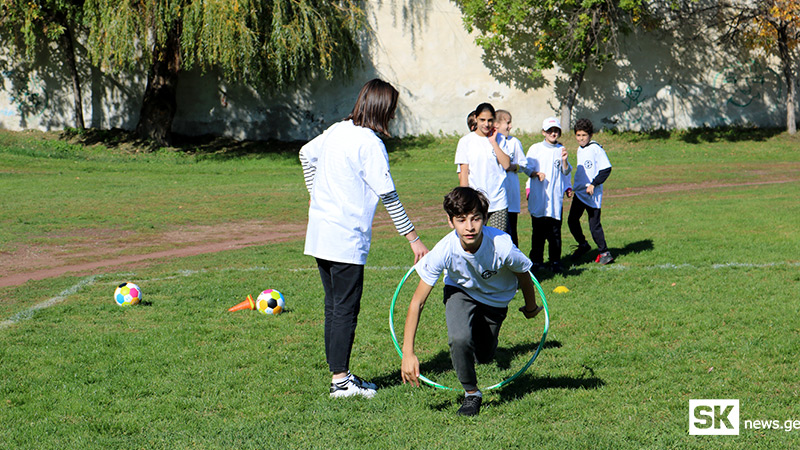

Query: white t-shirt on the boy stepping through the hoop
[414,226,531,308]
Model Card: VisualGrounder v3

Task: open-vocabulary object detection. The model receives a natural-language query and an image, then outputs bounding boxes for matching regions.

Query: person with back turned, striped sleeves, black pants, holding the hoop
[300,79,428,398]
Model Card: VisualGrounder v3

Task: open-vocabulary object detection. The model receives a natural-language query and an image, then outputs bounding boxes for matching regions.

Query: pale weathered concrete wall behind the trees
[0,0,786,140]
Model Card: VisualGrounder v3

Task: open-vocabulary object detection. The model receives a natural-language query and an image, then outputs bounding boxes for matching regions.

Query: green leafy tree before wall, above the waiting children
[453,0,655,127]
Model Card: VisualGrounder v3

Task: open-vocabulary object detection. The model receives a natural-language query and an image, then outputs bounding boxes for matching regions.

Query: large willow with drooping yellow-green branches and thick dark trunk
[84,0,364,145]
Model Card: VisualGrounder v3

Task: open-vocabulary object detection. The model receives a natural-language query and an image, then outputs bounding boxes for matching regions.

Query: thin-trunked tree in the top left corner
[0,0,84,130]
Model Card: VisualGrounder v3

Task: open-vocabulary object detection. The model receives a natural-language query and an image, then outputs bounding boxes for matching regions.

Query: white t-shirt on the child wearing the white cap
[526,141,572,220]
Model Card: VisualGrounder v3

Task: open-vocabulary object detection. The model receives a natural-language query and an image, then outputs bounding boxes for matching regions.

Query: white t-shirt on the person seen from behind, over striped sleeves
[302,120,395,265]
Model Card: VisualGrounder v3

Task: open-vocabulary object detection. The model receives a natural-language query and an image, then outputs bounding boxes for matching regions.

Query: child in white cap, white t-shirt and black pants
[525,117,572,273]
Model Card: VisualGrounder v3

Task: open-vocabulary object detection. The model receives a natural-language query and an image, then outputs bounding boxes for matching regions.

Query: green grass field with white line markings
[0,130,800,449]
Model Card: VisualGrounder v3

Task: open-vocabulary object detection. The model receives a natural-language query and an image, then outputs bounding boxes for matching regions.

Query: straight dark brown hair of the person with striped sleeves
[345,78,400,136]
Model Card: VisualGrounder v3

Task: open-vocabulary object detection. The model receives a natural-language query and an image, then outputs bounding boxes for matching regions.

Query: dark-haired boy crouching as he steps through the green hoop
[402,187,542,416]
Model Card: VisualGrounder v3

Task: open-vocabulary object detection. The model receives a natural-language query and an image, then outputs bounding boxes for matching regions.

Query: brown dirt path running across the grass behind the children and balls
[0,176,800,287]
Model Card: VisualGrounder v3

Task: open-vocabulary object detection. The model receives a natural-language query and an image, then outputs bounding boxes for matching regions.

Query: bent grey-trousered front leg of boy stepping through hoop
[444,286,478,392]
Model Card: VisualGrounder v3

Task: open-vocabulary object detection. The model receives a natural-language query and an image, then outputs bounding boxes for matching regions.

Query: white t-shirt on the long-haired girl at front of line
[455,132,508,212]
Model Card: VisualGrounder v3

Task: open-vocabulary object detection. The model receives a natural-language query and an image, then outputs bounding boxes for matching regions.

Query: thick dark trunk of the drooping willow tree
[136,25,181,146]
